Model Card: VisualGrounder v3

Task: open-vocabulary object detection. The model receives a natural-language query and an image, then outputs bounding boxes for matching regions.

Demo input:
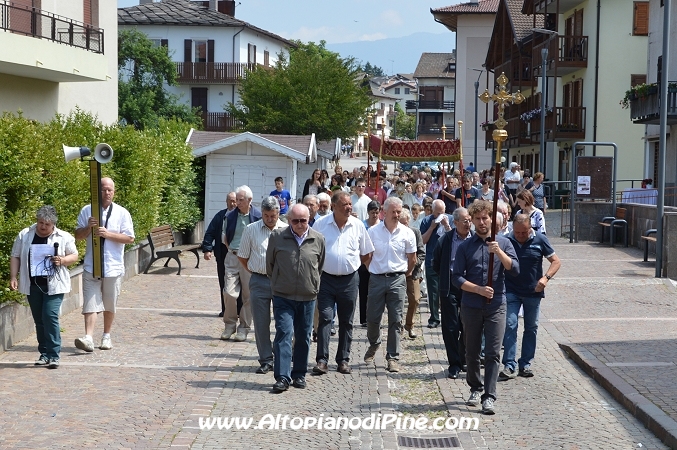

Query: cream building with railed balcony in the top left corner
[0,0,118,124]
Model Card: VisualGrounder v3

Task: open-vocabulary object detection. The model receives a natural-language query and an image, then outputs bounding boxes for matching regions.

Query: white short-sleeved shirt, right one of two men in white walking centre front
[368,222,416,274]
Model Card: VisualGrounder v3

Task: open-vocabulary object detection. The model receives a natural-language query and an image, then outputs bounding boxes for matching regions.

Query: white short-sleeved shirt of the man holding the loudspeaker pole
[77,202,134,277]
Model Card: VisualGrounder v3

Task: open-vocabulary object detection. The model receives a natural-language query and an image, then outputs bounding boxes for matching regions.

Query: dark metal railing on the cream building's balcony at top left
[0,3,103,53]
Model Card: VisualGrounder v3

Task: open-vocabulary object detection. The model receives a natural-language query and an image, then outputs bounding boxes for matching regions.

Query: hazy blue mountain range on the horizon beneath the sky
[326,32,456,75]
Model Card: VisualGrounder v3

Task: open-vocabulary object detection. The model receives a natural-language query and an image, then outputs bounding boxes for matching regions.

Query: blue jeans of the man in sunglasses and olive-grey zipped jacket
[273,296,315,383]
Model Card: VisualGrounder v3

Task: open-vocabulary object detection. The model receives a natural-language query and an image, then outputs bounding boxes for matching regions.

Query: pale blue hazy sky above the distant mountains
[117,0,465,44]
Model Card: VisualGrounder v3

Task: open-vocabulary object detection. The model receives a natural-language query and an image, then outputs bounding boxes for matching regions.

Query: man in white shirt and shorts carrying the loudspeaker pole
[75,178,134,352]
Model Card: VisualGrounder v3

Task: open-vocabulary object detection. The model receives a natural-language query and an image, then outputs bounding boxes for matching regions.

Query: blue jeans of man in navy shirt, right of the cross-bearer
[502,293,541,370]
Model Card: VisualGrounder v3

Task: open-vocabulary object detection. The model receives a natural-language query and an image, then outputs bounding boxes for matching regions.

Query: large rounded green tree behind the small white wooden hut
[226,41,371,141]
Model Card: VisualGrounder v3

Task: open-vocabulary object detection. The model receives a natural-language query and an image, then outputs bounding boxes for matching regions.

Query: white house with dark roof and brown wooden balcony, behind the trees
[118,0,294,131]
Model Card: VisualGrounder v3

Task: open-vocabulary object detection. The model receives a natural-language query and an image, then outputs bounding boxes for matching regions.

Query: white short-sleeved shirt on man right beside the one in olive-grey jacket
[313,213,374,275]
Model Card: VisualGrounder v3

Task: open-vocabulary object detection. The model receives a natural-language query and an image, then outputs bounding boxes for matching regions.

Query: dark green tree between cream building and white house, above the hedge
[118,30,201,130]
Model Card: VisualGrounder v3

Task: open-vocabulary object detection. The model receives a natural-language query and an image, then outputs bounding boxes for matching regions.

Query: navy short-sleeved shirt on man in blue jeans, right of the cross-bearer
[505,230,555,298]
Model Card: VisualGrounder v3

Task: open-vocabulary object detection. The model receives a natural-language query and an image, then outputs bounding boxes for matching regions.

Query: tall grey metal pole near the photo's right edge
[656,0,670,278]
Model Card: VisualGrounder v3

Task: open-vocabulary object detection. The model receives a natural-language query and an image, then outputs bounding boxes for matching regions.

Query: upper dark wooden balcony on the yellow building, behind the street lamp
[533,36,588,77]
